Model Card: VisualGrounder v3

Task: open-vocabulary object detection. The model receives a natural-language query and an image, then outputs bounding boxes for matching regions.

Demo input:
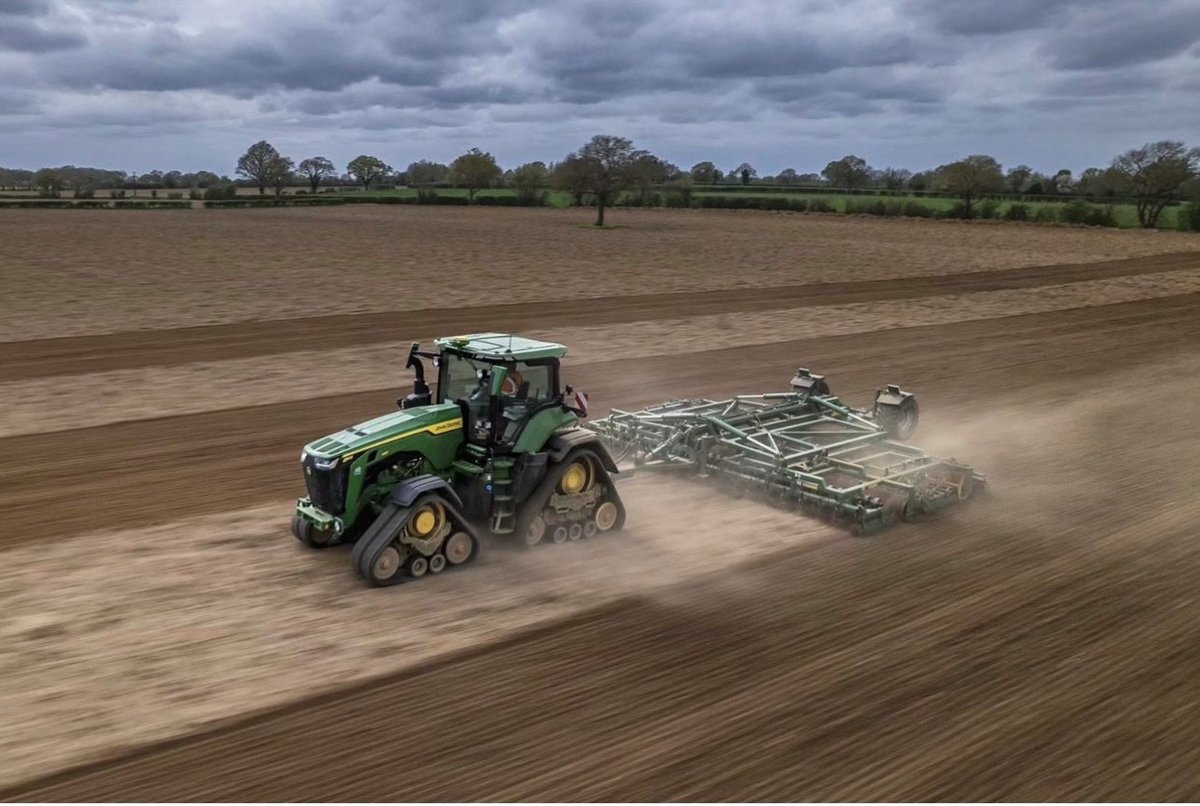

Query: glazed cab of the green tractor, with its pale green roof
[401,333,576,453]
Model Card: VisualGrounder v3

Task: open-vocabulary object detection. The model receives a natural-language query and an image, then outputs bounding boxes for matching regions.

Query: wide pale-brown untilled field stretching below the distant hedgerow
[0,205,1198,341]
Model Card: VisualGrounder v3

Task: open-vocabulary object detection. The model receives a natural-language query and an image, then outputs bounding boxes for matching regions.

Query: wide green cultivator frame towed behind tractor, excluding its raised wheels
[588,392,985,533]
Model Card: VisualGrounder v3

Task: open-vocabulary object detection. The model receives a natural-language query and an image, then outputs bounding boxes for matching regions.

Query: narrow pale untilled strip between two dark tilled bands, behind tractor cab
[0,269,1200,437]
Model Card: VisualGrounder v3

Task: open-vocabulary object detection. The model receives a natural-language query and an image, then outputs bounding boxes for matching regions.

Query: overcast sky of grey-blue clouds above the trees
[0,0,1200,174]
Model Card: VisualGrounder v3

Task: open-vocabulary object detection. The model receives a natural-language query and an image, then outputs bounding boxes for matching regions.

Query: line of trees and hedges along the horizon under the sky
[0,134,1200,228]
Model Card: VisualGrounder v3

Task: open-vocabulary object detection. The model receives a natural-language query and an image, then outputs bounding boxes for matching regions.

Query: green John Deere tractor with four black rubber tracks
[292,333,625,585]
